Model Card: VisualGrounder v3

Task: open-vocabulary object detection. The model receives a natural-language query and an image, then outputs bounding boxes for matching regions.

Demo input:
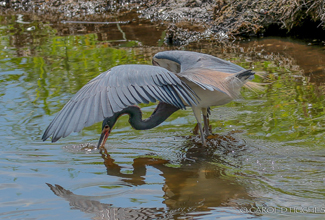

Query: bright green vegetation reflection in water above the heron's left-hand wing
[0,16,149,113]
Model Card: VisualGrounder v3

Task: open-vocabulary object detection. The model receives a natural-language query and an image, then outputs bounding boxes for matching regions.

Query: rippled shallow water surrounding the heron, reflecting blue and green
[0,15,325,219]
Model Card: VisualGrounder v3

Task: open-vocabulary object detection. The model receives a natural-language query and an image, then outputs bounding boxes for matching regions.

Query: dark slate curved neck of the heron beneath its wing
[121,102,179,130]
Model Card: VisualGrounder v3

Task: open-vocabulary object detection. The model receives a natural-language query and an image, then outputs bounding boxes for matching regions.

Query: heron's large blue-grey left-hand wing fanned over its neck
[42,65,197,142]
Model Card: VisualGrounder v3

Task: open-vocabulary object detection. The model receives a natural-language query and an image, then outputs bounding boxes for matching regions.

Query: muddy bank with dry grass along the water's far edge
[0,0,325,45]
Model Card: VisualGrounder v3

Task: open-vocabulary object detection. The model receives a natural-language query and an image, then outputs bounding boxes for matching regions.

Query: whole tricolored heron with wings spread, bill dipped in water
[42,51,255,149]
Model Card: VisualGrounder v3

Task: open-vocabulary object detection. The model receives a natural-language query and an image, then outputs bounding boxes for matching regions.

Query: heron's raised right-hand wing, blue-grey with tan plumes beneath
[153,51,254,98]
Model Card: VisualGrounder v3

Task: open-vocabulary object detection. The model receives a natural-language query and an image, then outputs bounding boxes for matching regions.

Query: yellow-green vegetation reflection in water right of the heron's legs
[225,58,325,144]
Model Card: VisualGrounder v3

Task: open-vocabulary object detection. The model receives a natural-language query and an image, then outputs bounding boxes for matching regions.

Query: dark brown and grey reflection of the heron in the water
[47,144,256,219]
